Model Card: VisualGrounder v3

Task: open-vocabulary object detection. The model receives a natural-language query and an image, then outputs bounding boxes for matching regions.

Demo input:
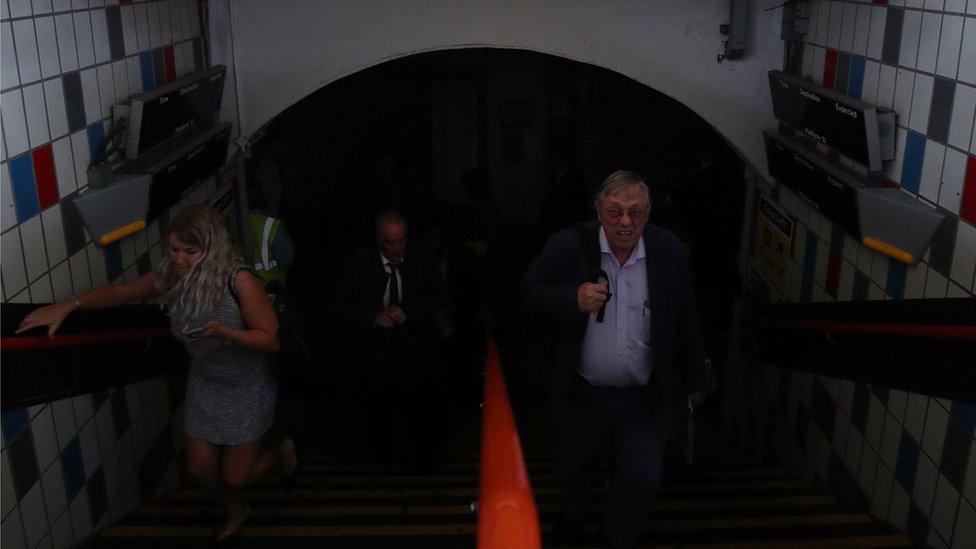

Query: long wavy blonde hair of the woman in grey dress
[156,205,240,319]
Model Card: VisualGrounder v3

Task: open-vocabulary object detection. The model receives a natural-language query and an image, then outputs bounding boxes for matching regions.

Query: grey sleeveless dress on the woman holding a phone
[169,280,278,445]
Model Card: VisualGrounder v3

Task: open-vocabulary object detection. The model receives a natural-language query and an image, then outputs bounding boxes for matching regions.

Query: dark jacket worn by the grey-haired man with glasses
[522,221,705,407]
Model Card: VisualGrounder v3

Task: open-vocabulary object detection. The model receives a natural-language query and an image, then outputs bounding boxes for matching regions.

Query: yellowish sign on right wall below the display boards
[756,196,793,295]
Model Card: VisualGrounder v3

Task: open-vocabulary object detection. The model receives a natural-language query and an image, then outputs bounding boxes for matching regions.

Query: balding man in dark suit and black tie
[332,212,447,463]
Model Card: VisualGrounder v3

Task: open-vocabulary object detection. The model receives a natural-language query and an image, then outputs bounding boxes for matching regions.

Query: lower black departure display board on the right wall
[763,130,866,240]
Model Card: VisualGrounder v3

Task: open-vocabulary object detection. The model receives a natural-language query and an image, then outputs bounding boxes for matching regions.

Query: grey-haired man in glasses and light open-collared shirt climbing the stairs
[522,171,705,547]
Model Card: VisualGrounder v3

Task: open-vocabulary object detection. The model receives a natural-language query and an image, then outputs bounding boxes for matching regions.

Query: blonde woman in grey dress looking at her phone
[17,206,298,542]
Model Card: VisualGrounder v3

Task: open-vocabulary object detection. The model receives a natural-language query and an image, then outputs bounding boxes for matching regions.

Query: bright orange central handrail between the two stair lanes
[478,336,542,549]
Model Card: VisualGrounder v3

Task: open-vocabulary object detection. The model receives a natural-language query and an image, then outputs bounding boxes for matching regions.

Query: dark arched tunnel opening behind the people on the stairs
[247,49,745,402]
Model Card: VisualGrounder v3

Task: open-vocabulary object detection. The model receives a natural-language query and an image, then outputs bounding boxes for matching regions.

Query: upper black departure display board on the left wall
[126,65,227,158]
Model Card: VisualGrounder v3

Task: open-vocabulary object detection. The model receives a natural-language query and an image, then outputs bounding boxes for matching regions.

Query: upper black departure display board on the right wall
[769,71,881,171]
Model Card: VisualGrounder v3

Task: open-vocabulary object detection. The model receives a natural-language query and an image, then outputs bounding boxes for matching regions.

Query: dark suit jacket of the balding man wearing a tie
[332,244,447,334]
